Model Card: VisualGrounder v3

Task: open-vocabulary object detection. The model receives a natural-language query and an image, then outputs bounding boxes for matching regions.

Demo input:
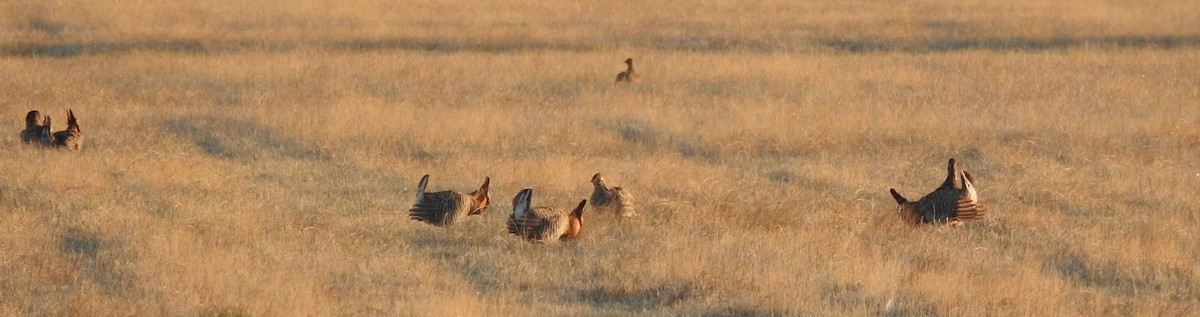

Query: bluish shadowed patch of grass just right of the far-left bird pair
[164,118,331,161]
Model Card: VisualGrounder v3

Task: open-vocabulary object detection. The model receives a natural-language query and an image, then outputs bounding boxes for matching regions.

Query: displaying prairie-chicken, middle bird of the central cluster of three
[508,189,588,244]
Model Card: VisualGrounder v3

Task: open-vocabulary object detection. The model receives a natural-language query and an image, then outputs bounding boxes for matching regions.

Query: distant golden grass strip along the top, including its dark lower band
[0,0,1198,55]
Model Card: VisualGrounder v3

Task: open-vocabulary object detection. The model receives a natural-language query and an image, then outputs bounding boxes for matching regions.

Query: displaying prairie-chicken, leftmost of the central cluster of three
[408,175,492,227]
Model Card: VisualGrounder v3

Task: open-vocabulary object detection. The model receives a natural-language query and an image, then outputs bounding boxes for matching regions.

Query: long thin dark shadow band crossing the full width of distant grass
[0,34,1200,58]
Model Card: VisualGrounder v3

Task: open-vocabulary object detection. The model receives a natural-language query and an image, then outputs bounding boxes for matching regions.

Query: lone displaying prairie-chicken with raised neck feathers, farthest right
[890,159,986,225]
